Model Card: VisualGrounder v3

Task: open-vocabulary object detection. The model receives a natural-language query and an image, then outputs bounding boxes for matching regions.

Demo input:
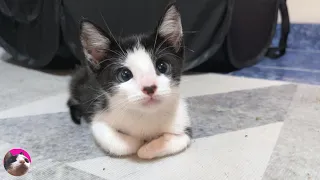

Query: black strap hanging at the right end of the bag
[266,0,290,59]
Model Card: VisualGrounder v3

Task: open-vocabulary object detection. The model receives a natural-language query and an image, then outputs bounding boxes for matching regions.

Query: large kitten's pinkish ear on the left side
[80,19,111,67]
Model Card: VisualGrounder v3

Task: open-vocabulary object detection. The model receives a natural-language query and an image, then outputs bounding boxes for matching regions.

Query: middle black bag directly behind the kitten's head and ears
[61,0,234,70]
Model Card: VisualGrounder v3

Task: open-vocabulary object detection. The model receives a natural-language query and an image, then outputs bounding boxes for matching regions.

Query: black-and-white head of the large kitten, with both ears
[80,4,184,109]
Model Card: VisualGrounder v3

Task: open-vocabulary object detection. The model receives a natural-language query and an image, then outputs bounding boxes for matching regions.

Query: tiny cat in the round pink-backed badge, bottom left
[4,152,30,176]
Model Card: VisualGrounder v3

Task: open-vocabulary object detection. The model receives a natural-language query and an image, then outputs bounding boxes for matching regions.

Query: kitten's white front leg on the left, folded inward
[91,122,143,156]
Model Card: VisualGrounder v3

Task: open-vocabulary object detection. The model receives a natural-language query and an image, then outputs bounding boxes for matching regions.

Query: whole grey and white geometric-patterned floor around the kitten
[0,64,320,180]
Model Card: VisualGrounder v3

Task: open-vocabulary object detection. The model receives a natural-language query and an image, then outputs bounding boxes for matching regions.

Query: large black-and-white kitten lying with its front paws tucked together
[68,3,191,159]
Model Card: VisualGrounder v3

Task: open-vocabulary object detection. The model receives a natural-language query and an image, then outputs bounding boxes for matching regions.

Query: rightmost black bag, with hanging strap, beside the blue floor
[187,0,290,72]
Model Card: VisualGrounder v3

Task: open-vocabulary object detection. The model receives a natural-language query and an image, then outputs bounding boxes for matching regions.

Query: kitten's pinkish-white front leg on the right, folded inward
[138,132,191,159]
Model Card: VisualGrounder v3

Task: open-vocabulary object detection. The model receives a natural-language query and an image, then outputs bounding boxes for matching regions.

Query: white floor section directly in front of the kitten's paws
[68,123,283,180]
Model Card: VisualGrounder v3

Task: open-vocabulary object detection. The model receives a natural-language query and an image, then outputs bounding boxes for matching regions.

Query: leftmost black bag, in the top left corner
[0,0,60,68]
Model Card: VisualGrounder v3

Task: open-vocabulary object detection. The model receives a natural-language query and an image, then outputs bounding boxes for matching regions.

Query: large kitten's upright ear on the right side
[157,3,183,51]
